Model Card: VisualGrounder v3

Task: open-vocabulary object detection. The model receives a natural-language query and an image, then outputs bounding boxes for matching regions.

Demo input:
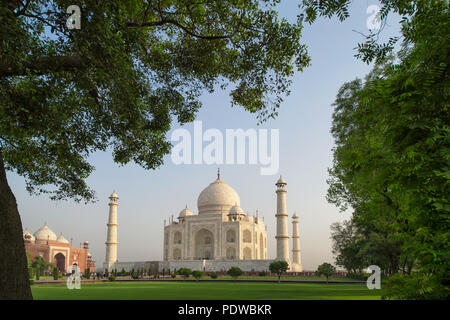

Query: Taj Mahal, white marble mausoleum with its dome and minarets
[103,170,302,272]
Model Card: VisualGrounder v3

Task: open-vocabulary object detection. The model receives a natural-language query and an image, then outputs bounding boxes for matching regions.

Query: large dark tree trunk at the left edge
[0,149,33,299]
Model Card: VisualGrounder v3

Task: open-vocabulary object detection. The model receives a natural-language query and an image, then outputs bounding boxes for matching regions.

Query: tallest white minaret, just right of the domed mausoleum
[275,176,289,263]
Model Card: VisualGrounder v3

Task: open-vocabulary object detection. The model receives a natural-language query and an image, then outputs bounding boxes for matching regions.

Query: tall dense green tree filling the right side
[328,1,450,299]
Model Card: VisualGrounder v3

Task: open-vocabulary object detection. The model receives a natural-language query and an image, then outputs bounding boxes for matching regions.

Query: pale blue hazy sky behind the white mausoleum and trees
[8,0,398,270]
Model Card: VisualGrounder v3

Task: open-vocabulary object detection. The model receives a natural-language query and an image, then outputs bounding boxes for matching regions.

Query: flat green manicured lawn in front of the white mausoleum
[32,281,382,300]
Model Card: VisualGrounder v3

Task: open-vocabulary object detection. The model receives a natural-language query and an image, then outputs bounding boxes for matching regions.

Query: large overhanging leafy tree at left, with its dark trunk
[0,0,309,299]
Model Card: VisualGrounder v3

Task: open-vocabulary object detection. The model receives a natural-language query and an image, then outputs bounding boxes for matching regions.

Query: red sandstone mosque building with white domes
[23,223,95,273]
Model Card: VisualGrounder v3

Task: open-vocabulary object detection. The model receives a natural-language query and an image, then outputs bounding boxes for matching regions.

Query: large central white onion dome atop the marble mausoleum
[197,178,241,216]
